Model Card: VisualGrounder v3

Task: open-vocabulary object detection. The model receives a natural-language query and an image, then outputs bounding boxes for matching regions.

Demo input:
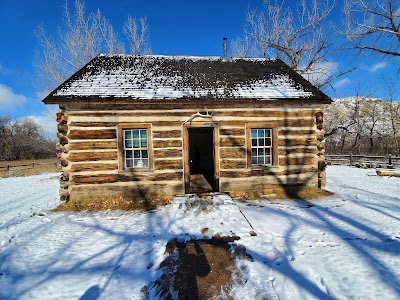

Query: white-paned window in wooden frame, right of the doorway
[247,124,278,166]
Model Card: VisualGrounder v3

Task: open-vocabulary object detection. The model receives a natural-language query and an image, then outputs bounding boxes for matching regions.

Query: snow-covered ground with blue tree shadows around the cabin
[0,166,400,299]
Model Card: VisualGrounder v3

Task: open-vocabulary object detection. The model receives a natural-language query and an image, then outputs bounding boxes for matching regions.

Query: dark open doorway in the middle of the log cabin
[187,127,218,193]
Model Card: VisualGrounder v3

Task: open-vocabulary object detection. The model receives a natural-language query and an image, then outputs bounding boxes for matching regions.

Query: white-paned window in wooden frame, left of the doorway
[118,124,152,170]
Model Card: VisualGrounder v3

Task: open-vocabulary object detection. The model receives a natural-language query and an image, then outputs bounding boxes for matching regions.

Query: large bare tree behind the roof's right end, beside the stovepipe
[242,0,348,87]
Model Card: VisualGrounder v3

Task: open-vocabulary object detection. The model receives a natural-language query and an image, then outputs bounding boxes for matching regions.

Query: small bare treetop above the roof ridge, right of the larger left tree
[123,15,150,55]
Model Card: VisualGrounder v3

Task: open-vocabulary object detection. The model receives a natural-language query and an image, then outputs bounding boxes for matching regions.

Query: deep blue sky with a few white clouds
[0,0,399,131]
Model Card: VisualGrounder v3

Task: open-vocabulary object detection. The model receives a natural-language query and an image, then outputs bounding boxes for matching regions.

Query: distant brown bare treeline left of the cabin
[0,116,57,161]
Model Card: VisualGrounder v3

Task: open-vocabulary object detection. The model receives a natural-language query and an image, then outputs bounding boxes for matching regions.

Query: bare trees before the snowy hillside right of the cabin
[325,97,400,156]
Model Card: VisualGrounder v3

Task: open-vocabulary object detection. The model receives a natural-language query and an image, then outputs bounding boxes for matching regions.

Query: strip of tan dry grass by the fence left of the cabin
[0,158,61,178]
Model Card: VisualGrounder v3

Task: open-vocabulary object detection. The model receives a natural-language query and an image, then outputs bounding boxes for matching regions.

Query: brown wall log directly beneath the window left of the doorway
[71,172,183,185]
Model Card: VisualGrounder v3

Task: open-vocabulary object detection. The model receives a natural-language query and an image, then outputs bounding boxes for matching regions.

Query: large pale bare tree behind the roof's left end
[34,0,148,92]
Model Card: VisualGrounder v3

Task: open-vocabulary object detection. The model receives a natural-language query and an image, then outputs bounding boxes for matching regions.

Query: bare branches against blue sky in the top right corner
[343,0,400,56]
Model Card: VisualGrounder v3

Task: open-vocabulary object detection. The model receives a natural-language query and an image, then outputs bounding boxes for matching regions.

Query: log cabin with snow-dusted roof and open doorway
[43,55,331,207]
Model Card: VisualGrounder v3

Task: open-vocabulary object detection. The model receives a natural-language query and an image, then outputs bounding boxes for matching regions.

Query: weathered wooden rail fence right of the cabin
[325,153,400,169]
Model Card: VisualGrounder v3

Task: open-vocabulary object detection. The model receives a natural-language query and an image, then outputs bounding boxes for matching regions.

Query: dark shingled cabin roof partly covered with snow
[43,55,331,104]
